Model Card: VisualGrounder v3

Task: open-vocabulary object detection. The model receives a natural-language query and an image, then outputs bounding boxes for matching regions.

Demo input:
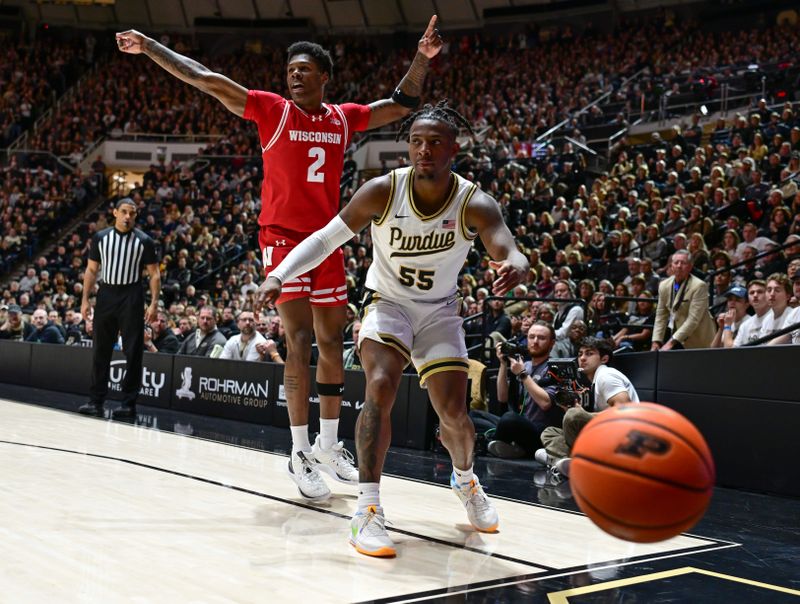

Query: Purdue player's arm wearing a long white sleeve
[254,175,391,312]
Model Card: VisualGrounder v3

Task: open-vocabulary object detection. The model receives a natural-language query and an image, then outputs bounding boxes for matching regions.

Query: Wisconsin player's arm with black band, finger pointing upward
[367,15,444,129]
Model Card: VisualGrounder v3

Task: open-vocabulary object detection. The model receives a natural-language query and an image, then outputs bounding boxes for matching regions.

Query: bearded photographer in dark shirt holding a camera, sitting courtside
[488,321,564,458]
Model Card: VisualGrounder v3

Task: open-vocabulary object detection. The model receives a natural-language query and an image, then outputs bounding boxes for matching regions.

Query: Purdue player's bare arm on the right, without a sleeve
[465,191,529,296]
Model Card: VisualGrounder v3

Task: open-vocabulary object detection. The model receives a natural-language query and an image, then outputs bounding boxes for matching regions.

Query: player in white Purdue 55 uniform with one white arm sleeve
[256,101,528,557]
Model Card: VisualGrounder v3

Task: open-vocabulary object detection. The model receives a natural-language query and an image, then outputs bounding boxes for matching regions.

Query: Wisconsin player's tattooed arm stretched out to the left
[116,29,247,117]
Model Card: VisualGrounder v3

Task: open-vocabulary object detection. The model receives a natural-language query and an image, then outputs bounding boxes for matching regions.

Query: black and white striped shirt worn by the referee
[89,227,158,285]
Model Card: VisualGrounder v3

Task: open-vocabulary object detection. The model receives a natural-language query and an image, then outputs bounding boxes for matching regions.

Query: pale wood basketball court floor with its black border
[0,385,800,604]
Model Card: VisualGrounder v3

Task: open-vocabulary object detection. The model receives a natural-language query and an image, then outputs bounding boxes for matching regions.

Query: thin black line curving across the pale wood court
[0,440,558,576]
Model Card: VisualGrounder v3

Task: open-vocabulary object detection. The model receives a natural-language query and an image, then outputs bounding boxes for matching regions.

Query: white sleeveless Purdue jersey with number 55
[366,168,477,301]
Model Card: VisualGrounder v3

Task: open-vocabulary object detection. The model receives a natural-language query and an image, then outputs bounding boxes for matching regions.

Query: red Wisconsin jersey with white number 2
[244,90,370,245]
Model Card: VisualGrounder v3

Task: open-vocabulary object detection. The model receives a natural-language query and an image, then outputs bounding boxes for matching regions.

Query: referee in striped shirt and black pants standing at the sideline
[78,198,161,419]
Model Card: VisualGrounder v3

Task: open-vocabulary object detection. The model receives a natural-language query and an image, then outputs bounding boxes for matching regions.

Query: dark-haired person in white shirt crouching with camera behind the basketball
[535,337,639,476]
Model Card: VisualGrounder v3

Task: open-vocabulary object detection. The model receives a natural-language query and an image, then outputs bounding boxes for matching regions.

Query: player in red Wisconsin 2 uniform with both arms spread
[116,15,442,501]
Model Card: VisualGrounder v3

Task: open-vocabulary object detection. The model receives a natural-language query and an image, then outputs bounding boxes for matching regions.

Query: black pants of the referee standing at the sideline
[89,283,144,405]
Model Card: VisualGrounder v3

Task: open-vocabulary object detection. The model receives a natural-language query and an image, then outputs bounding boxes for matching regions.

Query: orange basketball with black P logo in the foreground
[570,403,715,543]
